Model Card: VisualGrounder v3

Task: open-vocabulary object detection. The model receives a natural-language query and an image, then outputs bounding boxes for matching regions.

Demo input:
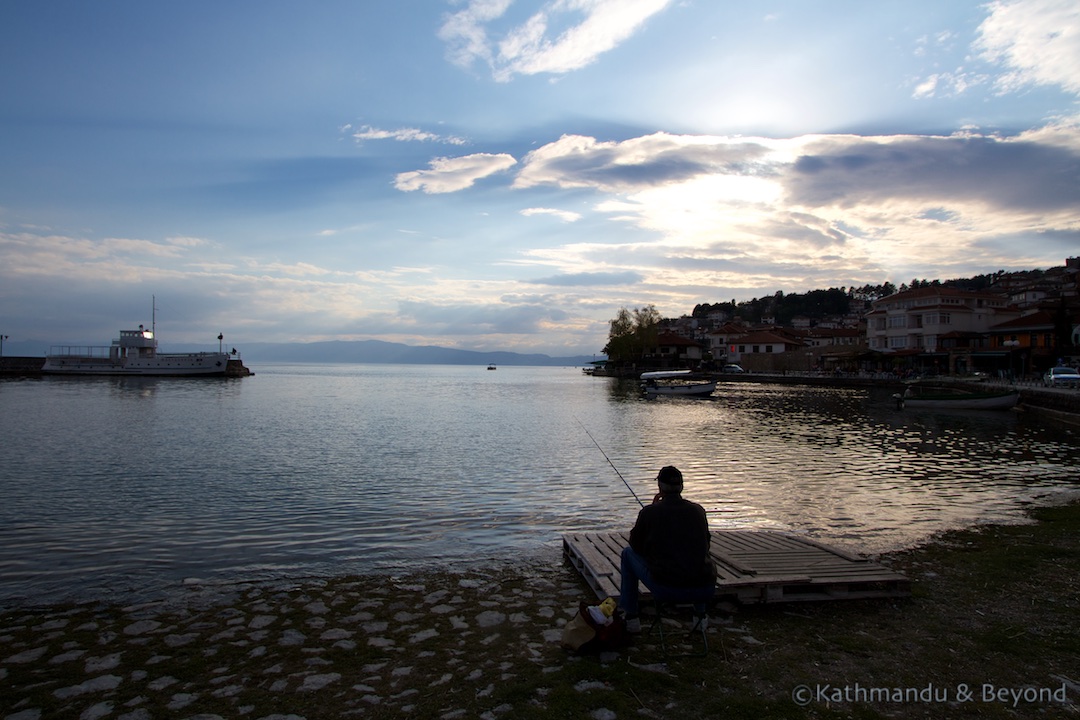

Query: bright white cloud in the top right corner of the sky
[975,0,1080,94]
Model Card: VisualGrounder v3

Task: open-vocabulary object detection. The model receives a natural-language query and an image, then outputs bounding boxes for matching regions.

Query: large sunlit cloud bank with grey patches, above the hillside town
[494,121,1080,308]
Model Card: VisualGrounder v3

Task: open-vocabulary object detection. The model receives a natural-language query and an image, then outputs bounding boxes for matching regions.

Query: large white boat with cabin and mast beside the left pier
[41,325,229,377]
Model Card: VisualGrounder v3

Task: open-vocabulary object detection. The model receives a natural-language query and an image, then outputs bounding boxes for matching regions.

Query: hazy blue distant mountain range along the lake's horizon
[3,340,597,367]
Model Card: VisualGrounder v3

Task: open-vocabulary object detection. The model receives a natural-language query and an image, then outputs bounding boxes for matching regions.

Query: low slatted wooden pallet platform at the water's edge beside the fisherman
[563,530,912,604]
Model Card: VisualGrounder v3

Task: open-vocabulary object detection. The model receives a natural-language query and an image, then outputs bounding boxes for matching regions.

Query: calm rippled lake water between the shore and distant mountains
[0,365,1080,606]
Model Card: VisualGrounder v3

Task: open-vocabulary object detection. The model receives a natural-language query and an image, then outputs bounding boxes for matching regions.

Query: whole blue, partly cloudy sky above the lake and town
[0,0,1080,356]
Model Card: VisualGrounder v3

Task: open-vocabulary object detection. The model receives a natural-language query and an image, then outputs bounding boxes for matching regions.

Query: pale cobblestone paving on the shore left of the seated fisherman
[0,565,704,720]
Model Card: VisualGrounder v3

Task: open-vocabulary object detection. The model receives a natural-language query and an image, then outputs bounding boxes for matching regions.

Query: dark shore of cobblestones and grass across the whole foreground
[0,504,1080,720]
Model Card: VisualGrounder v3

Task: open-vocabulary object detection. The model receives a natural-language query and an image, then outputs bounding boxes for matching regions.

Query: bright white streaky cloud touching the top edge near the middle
[438,0,672,82]
